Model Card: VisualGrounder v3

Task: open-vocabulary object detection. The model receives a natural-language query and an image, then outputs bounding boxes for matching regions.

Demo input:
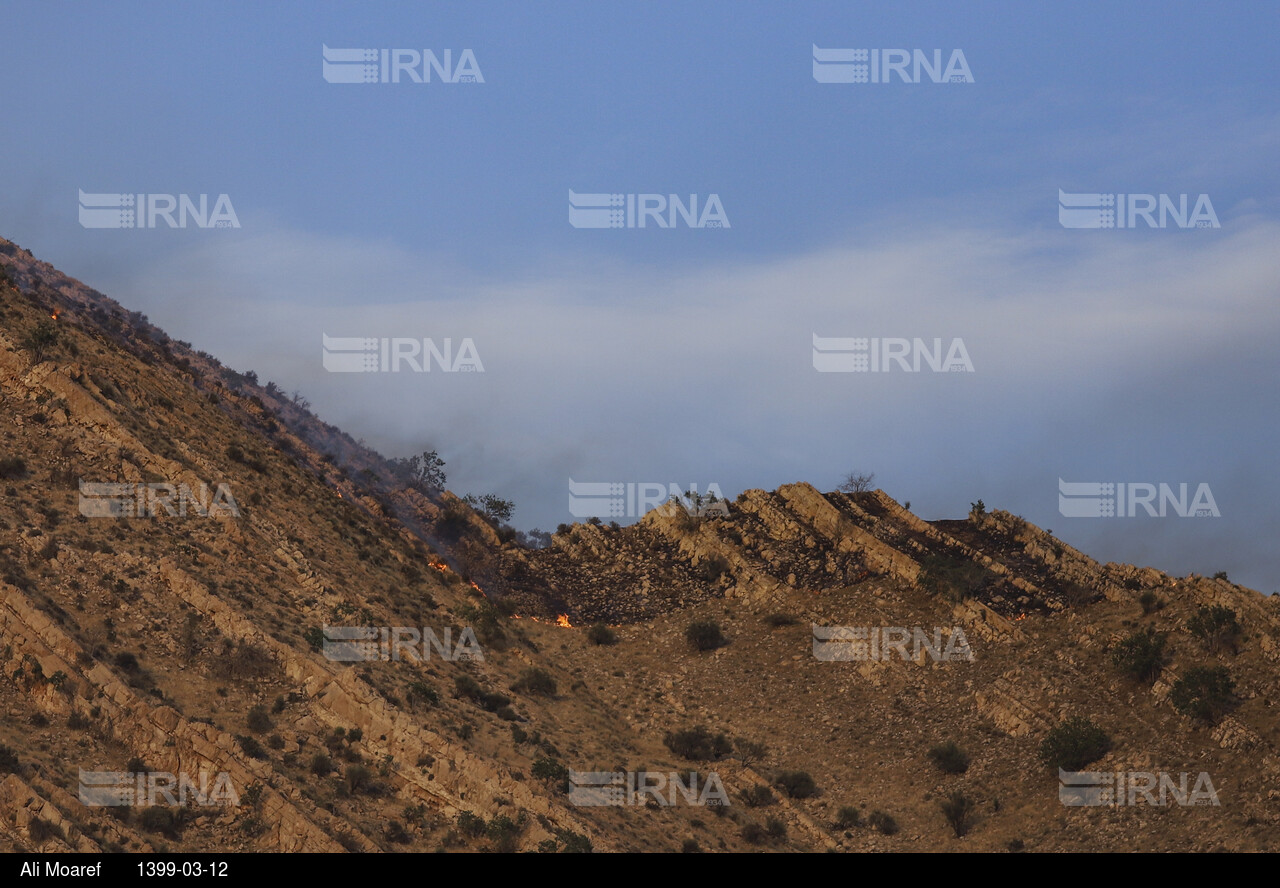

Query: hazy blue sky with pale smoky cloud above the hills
[0,0,1280,594]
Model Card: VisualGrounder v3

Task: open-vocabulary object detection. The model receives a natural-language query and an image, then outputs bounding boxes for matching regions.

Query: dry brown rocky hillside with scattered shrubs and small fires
[0,241,1280,851]
